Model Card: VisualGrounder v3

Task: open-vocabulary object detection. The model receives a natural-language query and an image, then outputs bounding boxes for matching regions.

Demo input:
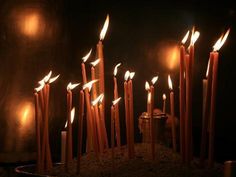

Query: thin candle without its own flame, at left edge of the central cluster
[77,90,84,174]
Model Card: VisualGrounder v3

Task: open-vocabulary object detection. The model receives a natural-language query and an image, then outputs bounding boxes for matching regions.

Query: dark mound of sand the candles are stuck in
[50,143,223,177]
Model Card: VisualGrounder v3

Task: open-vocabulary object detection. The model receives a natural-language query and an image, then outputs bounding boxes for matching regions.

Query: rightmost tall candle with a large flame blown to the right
[208,29,230,167]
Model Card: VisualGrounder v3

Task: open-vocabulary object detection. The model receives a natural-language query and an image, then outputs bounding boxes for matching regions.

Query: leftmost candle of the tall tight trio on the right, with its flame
[179,31,189,161]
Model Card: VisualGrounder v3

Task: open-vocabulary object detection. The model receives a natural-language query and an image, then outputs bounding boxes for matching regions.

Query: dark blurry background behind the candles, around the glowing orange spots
[0,0,236,165]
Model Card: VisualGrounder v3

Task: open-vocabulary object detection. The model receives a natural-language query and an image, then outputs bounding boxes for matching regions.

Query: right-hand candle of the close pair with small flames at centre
[128,72,135,158]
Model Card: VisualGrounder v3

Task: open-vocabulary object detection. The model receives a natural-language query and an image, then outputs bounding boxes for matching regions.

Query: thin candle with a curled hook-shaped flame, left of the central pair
[113,63,121,148]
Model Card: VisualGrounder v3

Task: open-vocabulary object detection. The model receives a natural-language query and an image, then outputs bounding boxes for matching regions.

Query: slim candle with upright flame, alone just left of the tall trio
[168,75,176,152]
